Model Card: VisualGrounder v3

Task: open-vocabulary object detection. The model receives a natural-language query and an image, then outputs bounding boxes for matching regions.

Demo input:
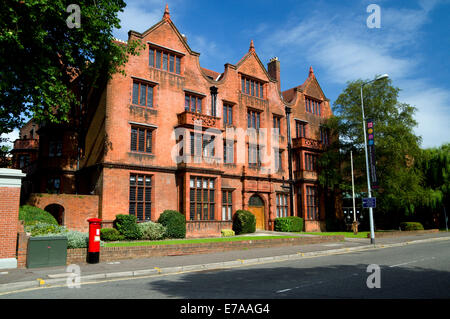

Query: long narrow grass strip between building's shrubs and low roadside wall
[104,236,297,247]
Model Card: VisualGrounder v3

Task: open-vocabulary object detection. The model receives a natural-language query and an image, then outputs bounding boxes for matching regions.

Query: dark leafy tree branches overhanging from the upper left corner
[0,0,142,134]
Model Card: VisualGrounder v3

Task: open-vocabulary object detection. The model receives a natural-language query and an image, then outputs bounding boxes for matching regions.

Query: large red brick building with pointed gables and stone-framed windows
[12,7,331,237]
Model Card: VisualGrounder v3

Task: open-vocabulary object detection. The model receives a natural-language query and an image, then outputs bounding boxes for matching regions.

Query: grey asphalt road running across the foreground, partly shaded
[0,241,450,299]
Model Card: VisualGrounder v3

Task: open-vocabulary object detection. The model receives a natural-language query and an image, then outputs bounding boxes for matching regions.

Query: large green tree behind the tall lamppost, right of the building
[319,79,424,227]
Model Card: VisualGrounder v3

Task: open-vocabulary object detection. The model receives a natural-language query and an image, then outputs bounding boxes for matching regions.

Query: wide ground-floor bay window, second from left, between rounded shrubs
[189,176,215,220]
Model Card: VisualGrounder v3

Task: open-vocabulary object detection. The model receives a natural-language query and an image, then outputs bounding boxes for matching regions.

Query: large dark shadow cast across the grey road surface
[148,264,450,299]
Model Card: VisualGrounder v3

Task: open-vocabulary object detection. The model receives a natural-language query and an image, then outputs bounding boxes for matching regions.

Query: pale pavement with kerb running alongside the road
[0,231,450,296]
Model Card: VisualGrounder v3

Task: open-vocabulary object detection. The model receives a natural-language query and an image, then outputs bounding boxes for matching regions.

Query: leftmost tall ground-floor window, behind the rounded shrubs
[129,174,152,221]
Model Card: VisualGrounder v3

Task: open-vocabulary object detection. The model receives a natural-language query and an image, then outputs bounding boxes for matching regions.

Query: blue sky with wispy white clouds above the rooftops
[1,0,450,147]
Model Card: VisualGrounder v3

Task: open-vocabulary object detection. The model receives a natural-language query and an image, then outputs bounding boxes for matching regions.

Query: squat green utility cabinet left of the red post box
[27,236,67,268]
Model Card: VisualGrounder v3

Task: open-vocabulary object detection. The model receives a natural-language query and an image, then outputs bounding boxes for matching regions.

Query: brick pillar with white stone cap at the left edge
[0,168,25,269]
